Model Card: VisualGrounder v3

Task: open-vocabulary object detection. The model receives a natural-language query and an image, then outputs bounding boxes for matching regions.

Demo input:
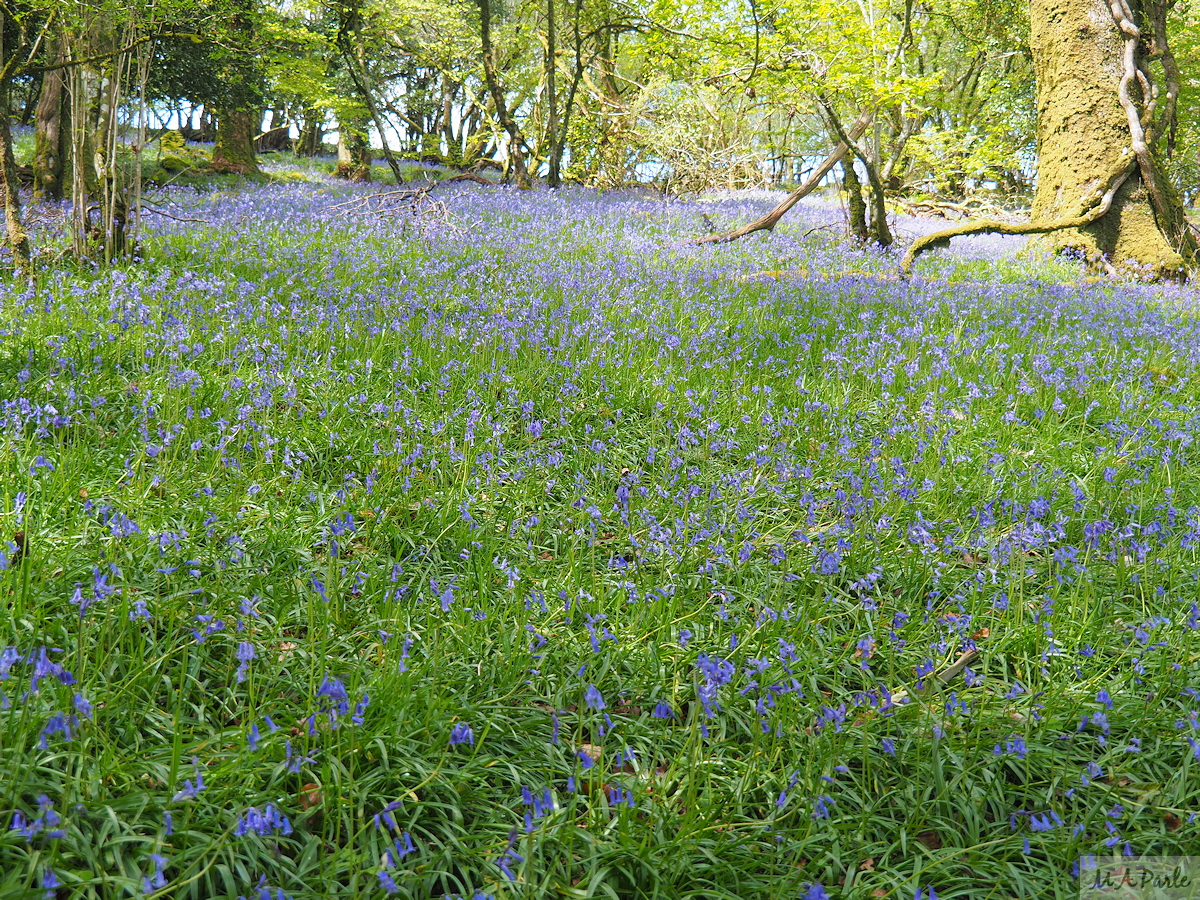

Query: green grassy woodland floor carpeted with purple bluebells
[0,175,1200,900]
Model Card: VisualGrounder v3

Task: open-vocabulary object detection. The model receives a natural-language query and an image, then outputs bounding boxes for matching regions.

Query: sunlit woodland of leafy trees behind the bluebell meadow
[14,0,1200,266]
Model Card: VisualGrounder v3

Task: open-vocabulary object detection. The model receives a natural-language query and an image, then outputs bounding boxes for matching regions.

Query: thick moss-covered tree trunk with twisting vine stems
[1030,0,1195,277]
